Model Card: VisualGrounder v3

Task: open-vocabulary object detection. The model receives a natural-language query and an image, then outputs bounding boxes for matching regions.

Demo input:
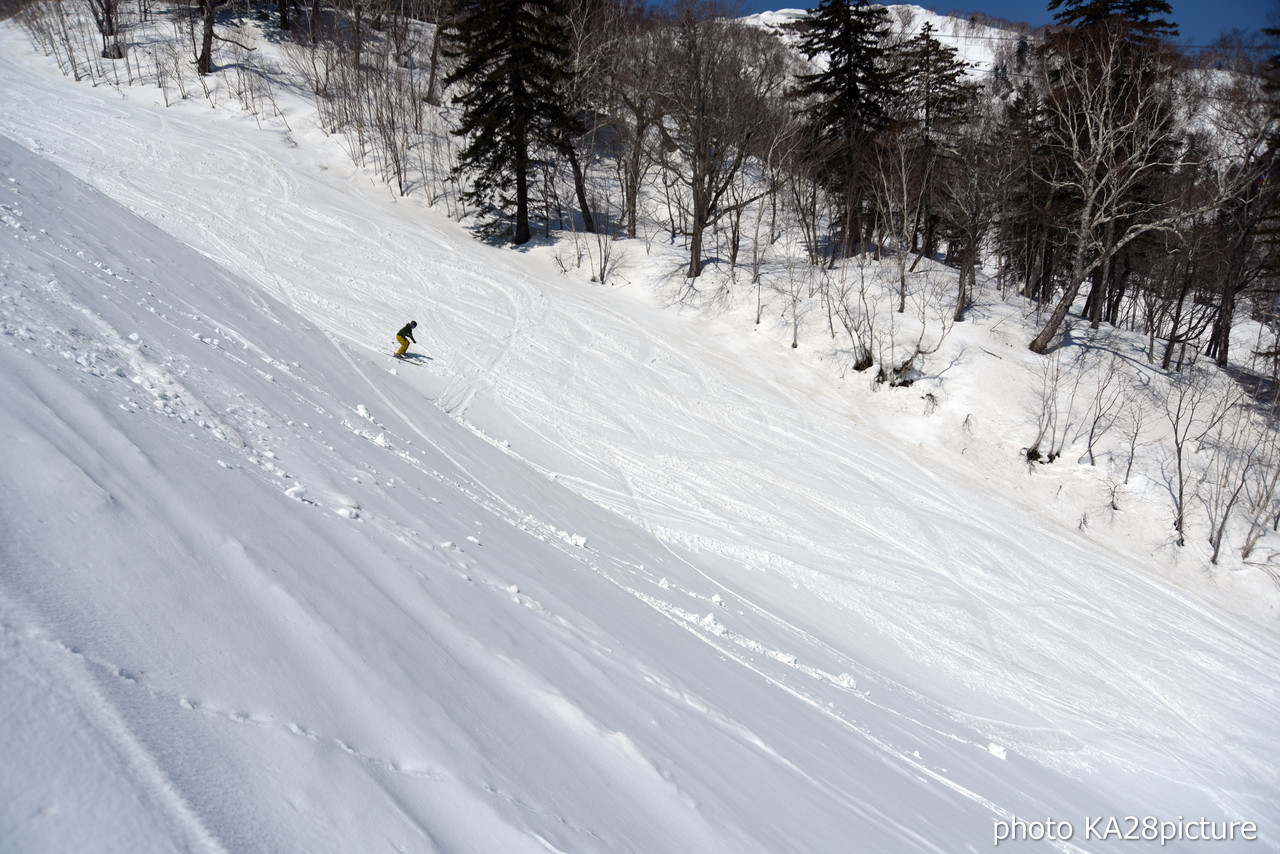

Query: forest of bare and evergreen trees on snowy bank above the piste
[18,0,1280,568]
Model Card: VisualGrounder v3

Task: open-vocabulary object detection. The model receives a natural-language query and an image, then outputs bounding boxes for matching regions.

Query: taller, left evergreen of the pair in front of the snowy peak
[796,0,893,251]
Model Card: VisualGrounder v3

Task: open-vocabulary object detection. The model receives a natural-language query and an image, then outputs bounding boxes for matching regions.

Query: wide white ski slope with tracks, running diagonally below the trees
[0,24,1280,854]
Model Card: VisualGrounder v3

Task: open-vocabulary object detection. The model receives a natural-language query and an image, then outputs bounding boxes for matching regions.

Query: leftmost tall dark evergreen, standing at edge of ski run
[445,0,582,245]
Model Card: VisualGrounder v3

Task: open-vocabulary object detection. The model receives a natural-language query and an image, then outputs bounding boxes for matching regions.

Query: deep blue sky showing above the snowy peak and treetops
[744,0,1280,45]
